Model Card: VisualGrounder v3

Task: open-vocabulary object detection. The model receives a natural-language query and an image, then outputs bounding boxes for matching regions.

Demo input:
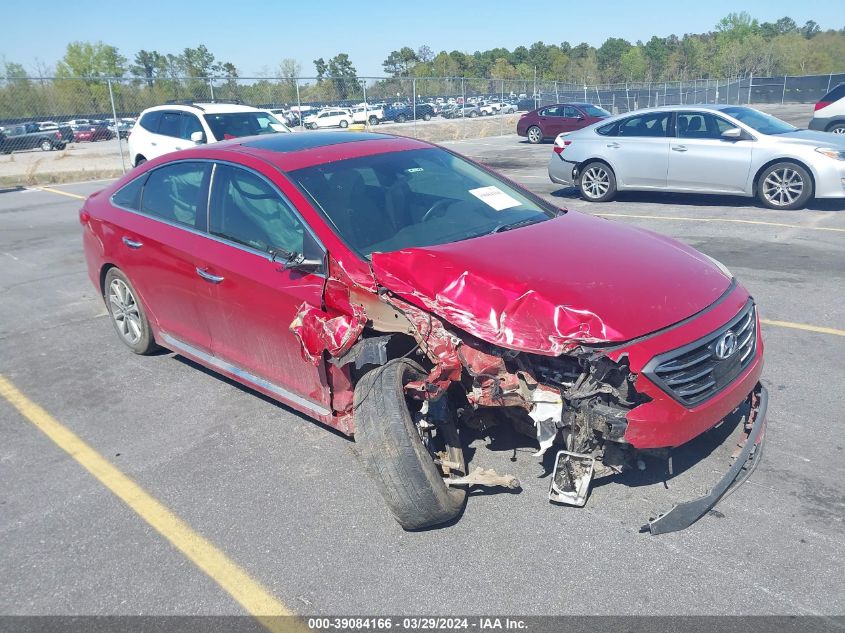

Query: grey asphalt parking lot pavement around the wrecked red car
[0,135,845,615]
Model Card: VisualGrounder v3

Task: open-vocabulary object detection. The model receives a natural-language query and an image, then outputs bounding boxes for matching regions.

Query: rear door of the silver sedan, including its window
[600,112,672,189]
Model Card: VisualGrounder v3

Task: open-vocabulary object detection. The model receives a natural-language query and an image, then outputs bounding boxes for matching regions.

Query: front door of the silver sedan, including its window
[667,111,754,193]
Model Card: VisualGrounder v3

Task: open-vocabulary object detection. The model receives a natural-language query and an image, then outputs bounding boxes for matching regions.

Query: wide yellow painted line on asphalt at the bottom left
[0,375,301,633]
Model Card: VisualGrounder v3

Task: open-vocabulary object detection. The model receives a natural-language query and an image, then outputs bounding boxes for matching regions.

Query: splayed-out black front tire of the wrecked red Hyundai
[354,358,466,530]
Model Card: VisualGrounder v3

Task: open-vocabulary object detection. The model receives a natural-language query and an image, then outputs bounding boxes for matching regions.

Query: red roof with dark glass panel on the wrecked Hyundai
[218,132,432,171]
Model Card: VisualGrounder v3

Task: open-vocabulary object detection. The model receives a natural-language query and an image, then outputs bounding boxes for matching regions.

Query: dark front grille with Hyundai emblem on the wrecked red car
[643,300,757,406]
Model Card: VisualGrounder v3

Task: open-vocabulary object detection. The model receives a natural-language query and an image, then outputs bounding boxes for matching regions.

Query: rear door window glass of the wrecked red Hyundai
[141,162,210,227]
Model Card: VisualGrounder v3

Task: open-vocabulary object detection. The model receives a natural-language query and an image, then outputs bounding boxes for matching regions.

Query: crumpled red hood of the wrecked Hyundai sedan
[372,211,731,355]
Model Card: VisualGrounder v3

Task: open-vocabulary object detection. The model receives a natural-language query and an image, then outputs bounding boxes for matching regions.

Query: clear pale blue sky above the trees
[0,0,845,77]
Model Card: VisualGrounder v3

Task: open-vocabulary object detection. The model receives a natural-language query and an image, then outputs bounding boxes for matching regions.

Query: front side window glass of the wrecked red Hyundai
[208,164,305,253]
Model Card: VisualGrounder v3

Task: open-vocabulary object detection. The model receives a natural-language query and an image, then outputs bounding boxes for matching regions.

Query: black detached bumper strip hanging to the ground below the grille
[640,383,769,535]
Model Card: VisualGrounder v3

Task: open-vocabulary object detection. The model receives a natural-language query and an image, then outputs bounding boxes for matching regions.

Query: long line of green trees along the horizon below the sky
[0,12,845,119]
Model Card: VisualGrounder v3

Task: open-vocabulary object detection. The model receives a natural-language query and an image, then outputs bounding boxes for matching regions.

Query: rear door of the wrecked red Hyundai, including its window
[105,161,211,350]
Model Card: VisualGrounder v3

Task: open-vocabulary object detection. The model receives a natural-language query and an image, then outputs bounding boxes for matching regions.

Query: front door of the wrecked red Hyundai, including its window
[200,163,329,415]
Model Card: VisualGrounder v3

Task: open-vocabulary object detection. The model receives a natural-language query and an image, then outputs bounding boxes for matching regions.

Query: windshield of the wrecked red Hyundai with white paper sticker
[289,148,558,257]
